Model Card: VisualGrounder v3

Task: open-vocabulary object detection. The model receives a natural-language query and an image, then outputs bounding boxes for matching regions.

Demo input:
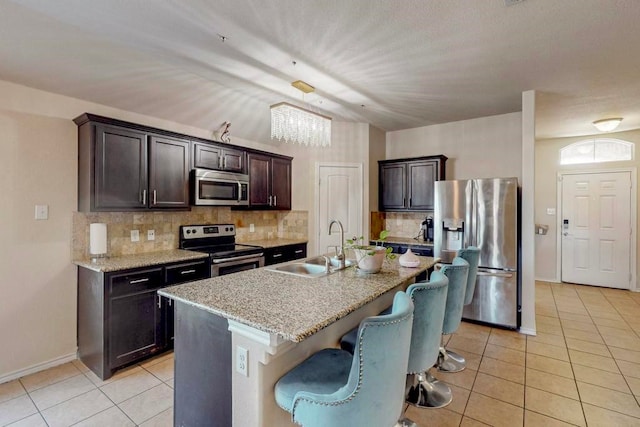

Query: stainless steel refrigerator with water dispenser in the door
[433,178,521,328]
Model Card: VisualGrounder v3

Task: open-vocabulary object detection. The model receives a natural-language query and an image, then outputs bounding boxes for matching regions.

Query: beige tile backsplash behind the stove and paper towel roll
[71,206,309,259]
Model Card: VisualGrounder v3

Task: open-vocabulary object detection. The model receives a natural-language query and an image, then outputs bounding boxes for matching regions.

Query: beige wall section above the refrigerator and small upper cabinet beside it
[386,112,522,179]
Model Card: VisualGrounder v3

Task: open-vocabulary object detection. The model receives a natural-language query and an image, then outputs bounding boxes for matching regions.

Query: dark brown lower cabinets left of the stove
[78,259,210,380]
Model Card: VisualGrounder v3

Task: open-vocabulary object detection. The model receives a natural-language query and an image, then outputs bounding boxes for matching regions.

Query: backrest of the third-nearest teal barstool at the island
[440,257,469,334]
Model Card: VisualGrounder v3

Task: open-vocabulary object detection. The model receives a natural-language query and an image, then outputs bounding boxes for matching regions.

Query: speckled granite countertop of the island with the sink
[158,257,435,342]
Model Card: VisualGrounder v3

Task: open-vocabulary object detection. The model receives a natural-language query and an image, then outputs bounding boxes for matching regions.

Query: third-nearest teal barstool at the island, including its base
[437,256,469,372]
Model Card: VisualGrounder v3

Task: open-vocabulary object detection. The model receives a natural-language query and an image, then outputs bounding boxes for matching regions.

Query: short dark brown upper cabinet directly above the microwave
[192,139,247,173]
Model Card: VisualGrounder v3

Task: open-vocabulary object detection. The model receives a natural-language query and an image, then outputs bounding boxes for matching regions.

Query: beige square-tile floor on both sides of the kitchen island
[0,282,640,427]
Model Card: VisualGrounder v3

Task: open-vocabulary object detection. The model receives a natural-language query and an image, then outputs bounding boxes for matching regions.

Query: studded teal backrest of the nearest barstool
[293,292,413,427]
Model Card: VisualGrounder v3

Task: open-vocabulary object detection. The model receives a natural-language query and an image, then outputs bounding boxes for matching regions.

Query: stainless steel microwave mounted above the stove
[190,169,249,206]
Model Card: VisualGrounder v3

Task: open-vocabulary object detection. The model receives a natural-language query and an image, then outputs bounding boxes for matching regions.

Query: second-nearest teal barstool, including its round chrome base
[404,271,452,412]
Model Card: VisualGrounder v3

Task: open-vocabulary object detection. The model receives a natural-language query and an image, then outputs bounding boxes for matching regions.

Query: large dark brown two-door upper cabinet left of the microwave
[75,114,189,212]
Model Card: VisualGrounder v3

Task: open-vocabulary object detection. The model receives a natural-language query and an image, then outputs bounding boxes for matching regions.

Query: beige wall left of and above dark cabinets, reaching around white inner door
[0,81,369,383]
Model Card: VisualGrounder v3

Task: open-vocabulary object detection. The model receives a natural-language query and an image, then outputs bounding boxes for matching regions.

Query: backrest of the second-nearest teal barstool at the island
[407,271,449,374]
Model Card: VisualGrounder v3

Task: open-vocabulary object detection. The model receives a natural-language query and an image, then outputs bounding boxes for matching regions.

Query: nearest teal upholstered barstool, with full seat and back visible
[275,292,413,427]
